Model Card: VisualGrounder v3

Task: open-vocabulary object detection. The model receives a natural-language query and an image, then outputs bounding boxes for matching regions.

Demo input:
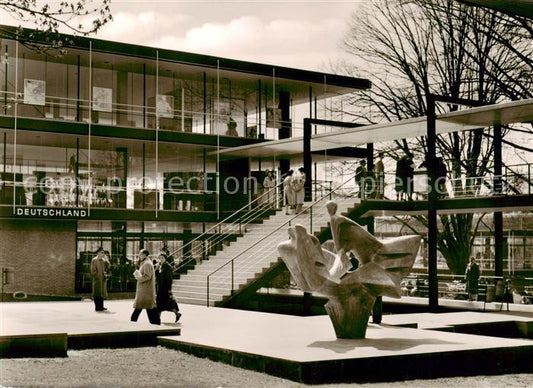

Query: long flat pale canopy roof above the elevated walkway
[219,99,533,158]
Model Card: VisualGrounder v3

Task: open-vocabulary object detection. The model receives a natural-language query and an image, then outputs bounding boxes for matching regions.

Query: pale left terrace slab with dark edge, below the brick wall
[0,301,181,357]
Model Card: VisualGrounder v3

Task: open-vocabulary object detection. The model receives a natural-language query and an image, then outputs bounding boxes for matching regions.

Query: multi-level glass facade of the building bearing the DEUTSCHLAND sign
[0,32,358,293]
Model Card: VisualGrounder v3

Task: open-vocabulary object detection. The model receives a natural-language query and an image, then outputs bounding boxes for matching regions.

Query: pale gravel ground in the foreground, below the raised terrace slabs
[0,347,533,388]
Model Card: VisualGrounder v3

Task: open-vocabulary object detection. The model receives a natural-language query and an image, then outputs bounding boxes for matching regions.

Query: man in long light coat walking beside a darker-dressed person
[131,249,161,325]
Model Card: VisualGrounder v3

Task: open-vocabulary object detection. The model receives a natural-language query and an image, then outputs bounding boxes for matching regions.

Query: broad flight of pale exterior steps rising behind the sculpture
[172,198,357,306]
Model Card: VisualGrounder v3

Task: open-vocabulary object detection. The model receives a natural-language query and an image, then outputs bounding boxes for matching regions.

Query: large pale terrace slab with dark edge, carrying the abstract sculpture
[159,305,533,384]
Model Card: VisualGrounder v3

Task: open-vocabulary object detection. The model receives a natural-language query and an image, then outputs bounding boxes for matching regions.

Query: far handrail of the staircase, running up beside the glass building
[170,183,283,271]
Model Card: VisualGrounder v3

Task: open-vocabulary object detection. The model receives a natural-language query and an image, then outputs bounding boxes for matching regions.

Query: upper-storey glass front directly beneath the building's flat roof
[0,39,290,138]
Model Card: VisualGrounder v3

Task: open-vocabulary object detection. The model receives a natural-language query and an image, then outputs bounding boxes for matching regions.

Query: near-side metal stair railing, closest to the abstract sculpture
[206,178,353,307]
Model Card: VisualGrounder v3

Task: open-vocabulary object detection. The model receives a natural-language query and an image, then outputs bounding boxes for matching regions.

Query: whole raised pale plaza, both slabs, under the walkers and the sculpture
[0,300,533,383]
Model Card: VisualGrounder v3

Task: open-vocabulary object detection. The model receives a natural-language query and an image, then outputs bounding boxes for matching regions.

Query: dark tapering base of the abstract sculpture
[325,293,376,339]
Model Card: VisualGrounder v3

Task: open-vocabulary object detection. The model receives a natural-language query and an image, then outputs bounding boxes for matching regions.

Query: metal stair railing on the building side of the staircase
[170,183,283,272]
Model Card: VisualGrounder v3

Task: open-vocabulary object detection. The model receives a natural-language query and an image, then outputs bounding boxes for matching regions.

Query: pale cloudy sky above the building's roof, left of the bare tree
[0,0,362,71]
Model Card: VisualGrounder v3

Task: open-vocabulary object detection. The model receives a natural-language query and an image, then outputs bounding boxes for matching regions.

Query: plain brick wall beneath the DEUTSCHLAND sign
[0,220,76,296]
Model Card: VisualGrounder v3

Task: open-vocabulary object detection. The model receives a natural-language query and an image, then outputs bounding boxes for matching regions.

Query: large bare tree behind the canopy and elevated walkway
[343,0,533,273]
